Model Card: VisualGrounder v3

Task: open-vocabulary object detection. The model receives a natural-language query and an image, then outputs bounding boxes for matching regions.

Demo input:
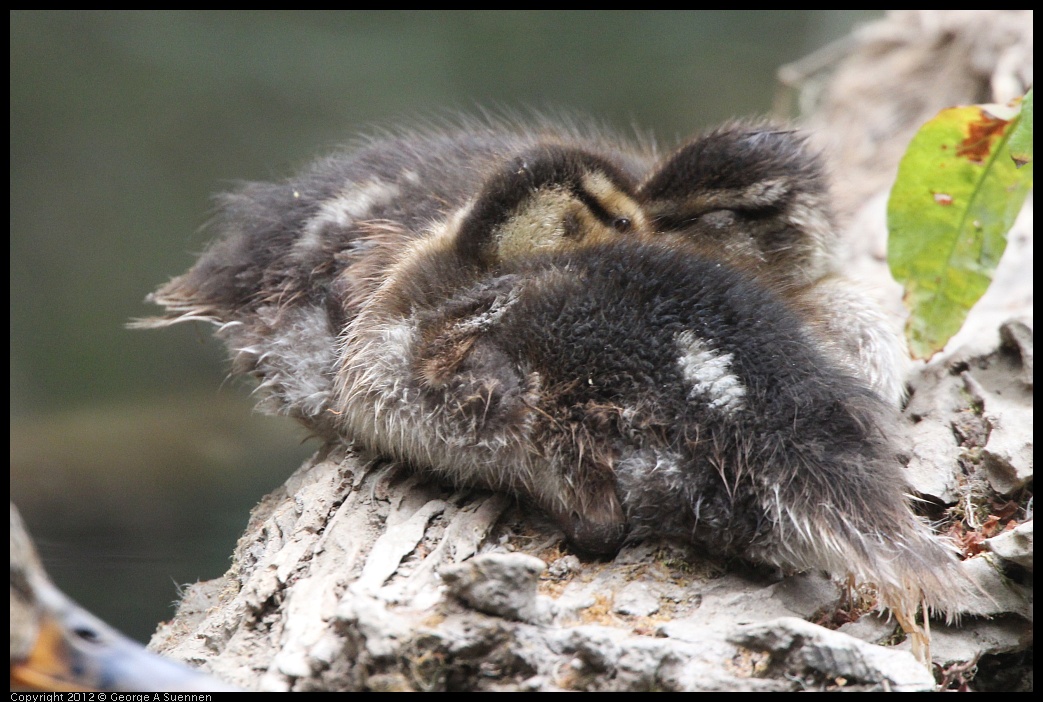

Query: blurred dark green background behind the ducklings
[10,10,879,640]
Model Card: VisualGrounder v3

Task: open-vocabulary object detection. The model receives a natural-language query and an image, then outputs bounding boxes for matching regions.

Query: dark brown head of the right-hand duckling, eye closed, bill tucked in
[637,123,836,284]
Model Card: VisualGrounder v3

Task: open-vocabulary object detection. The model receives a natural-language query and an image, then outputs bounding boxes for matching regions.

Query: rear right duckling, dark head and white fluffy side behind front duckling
[638,122,908,406]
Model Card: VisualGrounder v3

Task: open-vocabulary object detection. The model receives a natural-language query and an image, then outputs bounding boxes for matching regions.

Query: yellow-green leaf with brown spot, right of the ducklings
[888,105,1032,358]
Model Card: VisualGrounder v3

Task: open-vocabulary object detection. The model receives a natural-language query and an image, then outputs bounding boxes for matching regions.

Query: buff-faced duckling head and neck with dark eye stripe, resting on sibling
[356,142,649,326]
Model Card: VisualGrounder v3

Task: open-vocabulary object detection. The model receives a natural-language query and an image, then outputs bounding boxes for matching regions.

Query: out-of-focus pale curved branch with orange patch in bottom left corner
[10,504,237,693]
